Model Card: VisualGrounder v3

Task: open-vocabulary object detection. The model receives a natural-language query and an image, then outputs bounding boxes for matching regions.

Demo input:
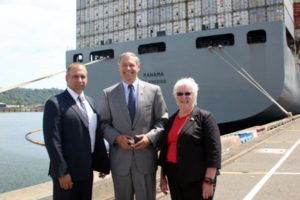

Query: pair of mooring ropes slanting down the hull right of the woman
[208,44,293,117]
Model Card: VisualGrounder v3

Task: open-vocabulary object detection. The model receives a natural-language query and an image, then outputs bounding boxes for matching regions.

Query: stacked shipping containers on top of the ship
[76,0,292,48]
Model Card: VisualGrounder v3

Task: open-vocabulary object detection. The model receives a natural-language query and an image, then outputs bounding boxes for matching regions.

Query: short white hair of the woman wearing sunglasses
[173,77,199,105]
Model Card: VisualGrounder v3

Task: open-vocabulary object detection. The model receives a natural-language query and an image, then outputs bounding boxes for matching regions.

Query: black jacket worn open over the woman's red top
[159,107,221,181]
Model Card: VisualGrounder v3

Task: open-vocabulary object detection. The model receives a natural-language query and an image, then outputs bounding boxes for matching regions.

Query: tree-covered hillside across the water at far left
[0,88,63,106]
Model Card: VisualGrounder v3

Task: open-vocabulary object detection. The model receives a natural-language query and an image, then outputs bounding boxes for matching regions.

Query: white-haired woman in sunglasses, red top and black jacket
[159,78,221,200]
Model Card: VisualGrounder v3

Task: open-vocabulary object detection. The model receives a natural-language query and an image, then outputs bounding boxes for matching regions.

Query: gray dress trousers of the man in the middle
[112,159,156,200]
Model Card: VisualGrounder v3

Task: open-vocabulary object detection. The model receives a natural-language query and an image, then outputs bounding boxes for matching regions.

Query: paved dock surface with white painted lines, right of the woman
[215,120,300,200]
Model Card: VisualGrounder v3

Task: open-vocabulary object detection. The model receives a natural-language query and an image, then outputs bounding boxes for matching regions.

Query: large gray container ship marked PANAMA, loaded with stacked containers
[66,0,300,134]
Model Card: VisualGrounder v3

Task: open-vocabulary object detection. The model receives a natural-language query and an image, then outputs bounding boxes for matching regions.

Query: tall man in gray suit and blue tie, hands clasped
[100,52,168,200]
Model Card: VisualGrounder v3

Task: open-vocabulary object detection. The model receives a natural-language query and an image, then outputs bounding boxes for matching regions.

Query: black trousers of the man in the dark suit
[52,173,93,200]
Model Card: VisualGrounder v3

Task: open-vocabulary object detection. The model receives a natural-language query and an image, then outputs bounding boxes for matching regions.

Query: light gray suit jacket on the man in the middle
[100,80,168,175]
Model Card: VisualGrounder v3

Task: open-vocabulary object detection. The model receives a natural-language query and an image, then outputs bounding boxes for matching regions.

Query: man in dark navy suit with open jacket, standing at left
[43,63,109,200]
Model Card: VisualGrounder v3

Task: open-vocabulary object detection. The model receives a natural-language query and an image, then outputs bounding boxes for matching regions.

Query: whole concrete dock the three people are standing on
[0,116,300,200]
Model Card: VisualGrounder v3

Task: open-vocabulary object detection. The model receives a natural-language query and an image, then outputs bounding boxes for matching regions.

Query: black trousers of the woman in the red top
[166,163,215,200]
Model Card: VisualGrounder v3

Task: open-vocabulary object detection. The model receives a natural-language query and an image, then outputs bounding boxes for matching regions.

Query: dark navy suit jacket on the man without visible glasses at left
[43,90,109,181]
